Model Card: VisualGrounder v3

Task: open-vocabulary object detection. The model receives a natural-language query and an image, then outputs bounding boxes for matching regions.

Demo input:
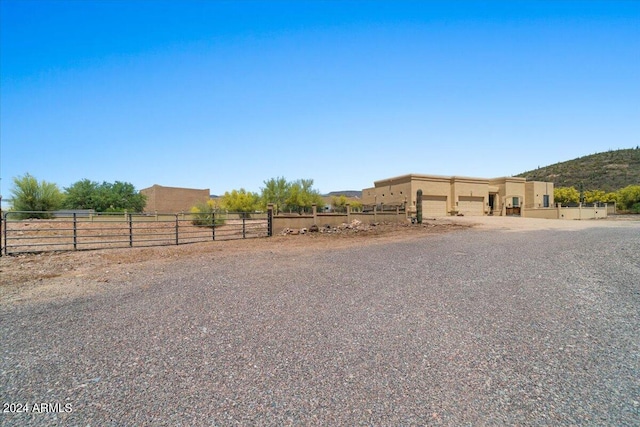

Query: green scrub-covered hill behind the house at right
[516,147,640,192]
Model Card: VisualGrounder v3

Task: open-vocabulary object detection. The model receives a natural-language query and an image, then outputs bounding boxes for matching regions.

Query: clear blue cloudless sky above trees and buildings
[0,0,640,198]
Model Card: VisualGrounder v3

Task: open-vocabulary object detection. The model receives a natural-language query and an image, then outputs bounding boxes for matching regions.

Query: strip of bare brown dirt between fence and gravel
[0,216,640,305]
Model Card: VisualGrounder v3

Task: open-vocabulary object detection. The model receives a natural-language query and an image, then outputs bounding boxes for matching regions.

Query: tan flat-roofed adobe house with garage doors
[362,174,554,217]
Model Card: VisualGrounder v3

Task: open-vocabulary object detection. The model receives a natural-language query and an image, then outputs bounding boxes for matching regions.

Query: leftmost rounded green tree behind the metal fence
[11,173,64,218]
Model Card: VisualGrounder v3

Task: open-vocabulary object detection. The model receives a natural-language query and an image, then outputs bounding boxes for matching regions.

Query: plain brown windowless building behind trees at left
[140,184,210,213]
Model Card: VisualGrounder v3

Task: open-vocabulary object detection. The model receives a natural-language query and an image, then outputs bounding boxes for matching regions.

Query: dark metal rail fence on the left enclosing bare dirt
[0,211,271,255]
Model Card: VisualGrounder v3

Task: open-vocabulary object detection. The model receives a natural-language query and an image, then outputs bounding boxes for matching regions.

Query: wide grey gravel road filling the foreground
[0,222,640,426]
